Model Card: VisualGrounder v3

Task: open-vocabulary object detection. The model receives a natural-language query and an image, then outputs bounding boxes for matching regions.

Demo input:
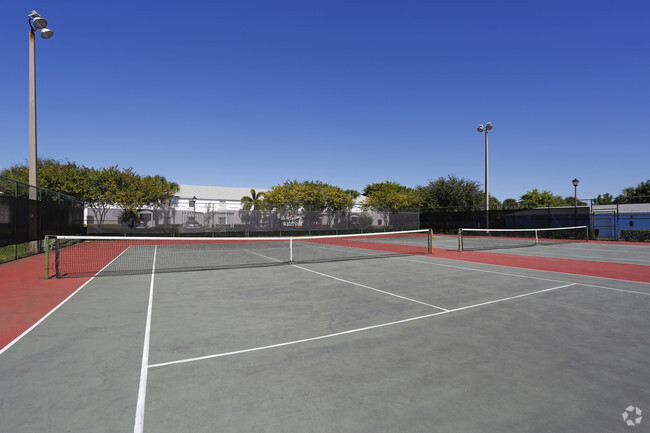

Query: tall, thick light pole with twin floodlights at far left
[27,11,54,252]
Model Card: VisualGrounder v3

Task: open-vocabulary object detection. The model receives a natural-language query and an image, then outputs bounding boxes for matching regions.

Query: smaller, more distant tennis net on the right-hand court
[458,226,589,251]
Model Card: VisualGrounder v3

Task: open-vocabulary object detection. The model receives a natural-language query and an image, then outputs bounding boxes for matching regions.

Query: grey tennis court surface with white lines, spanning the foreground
[0,233,650,432]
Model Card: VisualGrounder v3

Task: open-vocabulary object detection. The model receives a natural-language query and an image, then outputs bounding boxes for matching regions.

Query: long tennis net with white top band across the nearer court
[45,230,432,278]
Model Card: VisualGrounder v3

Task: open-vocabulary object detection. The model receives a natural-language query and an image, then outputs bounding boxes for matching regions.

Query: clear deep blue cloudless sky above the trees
[0,0,650,200]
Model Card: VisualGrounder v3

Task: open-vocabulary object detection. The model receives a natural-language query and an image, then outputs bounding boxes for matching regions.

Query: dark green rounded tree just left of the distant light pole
[418,174,486,209]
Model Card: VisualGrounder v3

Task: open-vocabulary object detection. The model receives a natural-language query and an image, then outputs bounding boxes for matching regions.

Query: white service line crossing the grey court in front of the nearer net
[149,283,577,368]
